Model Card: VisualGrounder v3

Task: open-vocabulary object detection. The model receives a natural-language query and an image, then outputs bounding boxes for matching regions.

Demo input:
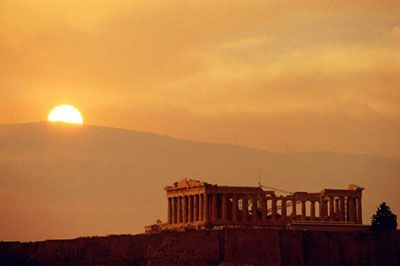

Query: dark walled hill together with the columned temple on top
[0,179,400,266]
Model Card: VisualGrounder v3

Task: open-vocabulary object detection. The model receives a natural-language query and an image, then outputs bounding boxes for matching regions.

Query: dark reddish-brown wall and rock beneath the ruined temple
[0,229,400,266]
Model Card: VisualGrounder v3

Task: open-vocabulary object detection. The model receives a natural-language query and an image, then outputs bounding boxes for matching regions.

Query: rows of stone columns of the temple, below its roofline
[168,193,362,224]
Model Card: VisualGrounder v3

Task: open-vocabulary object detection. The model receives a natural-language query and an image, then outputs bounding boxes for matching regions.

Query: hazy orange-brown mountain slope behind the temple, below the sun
[0,122,400,240]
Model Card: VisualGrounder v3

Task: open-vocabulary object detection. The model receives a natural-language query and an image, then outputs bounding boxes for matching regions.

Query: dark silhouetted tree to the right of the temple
[371,202,397,231]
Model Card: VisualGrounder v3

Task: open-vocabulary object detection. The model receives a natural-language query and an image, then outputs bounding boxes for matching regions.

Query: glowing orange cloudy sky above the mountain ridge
[0,0,400,157]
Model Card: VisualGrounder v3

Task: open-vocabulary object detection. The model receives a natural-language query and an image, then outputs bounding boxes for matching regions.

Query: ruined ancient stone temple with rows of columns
[146,179,363,232]
